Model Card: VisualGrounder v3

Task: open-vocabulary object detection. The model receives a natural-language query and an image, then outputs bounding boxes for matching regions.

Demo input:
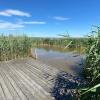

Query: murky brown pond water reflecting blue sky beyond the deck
[32,47,84,74]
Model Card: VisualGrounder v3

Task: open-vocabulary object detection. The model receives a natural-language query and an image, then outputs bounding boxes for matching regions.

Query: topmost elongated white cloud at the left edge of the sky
[0,9,31,17]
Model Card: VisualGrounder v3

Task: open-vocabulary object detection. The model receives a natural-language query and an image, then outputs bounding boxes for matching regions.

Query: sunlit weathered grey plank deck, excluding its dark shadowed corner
[0,58,59,100]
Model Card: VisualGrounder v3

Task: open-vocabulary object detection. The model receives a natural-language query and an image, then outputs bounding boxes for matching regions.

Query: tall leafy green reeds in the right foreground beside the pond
[81,27,100,100]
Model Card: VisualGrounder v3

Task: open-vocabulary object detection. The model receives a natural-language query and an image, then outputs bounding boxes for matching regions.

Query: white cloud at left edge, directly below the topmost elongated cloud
[0,22,24,30]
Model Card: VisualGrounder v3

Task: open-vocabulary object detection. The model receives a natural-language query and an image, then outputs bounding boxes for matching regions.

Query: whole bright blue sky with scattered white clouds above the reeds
[0,0,100,37]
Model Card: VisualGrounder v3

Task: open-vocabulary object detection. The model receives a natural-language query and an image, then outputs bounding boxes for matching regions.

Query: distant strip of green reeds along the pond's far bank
[31,37,88,48]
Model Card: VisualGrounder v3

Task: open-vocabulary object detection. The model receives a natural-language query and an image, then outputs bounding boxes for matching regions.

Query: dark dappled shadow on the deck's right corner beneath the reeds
[51,72,85,100]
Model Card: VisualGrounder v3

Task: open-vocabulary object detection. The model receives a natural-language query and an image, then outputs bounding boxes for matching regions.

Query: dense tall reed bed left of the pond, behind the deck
[0,35,31,61]
